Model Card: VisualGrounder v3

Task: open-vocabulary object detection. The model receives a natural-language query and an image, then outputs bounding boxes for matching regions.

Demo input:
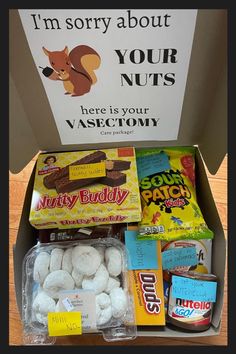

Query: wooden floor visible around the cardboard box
[9,156,228,346]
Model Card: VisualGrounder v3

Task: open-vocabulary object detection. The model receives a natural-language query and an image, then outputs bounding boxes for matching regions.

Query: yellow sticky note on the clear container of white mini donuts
[48,312,82,337]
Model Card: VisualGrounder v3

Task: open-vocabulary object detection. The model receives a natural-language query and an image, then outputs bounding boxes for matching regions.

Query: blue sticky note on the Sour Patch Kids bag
[136,152,170,180]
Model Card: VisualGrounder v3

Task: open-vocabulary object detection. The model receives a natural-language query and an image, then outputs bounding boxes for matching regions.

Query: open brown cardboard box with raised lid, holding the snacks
[10,10,227,337]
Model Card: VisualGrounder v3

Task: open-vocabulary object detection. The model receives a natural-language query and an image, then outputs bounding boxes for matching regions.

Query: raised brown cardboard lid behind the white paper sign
[10,10,227,173]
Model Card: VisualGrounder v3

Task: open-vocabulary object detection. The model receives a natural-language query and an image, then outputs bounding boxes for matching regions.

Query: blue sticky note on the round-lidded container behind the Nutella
[162,246,198,269]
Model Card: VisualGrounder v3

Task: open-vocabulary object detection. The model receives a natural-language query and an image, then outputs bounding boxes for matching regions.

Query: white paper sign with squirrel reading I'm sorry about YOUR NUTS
[19,9,197,145]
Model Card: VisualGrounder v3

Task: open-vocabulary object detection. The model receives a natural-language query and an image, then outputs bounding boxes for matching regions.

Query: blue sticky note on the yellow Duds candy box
[125,231,158,270]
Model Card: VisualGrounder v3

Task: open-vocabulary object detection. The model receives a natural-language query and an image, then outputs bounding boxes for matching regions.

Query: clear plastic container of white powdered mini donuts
[22,237,137,345]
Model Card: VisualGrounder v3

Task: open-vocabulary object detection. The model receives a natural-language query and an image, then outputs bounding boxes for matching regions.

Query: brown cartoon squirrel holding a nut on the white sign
[43,45,101,96]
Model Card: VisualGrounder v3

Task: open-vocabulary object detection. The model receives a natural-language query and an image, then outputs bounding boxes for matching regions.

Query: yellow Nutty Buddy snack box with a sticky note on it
[29,147,141,229]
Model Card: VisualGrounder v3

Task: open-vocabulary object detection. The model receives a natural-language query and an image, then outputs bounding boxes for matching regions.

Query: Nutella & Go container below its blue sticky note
[166,271,217,332]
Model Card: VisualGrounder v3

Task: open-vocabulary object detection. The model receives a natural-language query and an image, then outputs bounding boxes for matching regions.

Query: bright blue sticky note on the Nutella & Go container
[172,275,217,302]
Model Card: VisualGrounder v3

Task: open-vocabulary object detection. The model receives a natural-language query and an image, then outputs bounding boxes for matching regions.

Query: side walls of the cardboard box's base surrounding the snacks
[13,150,226,337]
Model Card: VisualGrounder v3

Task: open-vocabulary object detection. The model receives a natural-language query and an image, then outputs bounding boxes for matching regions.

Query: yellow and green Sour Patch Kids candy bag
[136,147,213,241]
